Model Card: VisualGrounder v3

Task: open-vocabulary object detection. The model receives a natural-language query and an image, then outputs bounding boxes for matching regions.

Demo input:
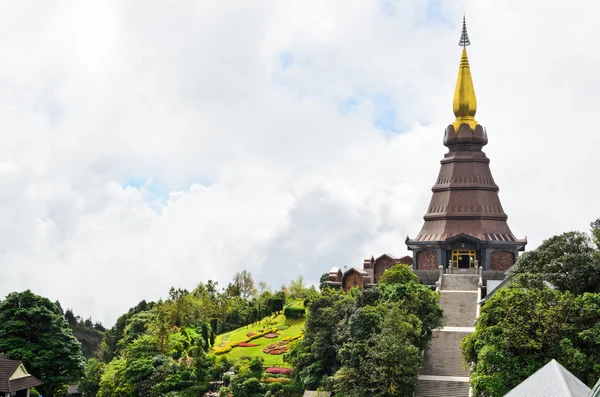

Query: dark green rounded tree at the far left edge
[0,290,85,396]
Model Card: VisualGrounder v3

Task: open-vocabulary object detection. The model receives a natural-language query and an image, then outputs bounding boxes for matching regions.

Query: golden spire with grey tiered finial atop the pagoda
[452,16,478,133]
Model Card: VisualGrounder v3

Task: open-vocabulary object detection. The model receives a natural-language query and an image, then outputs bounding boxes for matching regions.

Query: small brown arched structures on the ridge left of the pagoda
[328,254,412,291]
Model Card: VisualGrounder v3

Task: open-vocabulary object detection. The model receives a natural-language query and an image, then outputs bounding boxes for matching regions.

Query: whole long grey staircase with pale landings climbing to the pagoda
[415,274,479,397]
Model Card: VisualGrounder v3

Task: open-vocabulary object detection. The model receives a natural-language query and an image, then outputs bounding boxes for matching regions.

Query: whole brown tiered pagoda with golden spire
[406,18,527,271]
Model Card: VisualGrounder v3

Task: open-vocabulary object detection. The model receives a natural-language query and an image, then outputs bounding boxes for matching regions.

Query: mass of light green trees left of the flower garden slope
[91,272,297,397]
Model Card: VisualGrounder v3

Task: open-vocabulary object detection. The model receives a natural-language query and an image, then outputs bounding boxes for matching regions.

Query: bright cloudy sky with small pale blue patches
[0,0,600,326]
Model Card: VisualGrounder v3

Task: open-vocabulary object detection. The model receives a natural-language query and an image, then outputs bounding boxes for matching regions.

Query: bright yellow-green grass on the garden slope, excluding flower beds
[215,301,305,366]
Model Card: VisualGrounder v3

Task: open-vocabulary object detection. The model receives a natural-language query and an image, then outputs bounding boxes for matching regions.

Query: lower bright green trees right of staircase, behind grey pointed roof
[461,286,600,397]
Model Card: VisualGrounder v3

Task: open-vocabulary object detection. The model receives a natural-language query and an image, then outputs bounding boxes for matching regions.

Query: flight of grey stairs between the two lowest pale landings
[421,331,469,377]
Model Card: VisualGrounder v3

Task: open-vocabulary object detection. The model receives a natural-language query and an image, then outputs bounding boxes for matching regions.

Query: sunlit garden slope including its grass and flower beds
[214,301,306,366]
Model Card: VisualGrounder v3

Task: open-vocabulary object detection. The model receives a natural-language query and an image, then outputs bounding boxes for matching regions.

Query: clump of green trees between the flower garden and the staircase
[286,267,442,396]
